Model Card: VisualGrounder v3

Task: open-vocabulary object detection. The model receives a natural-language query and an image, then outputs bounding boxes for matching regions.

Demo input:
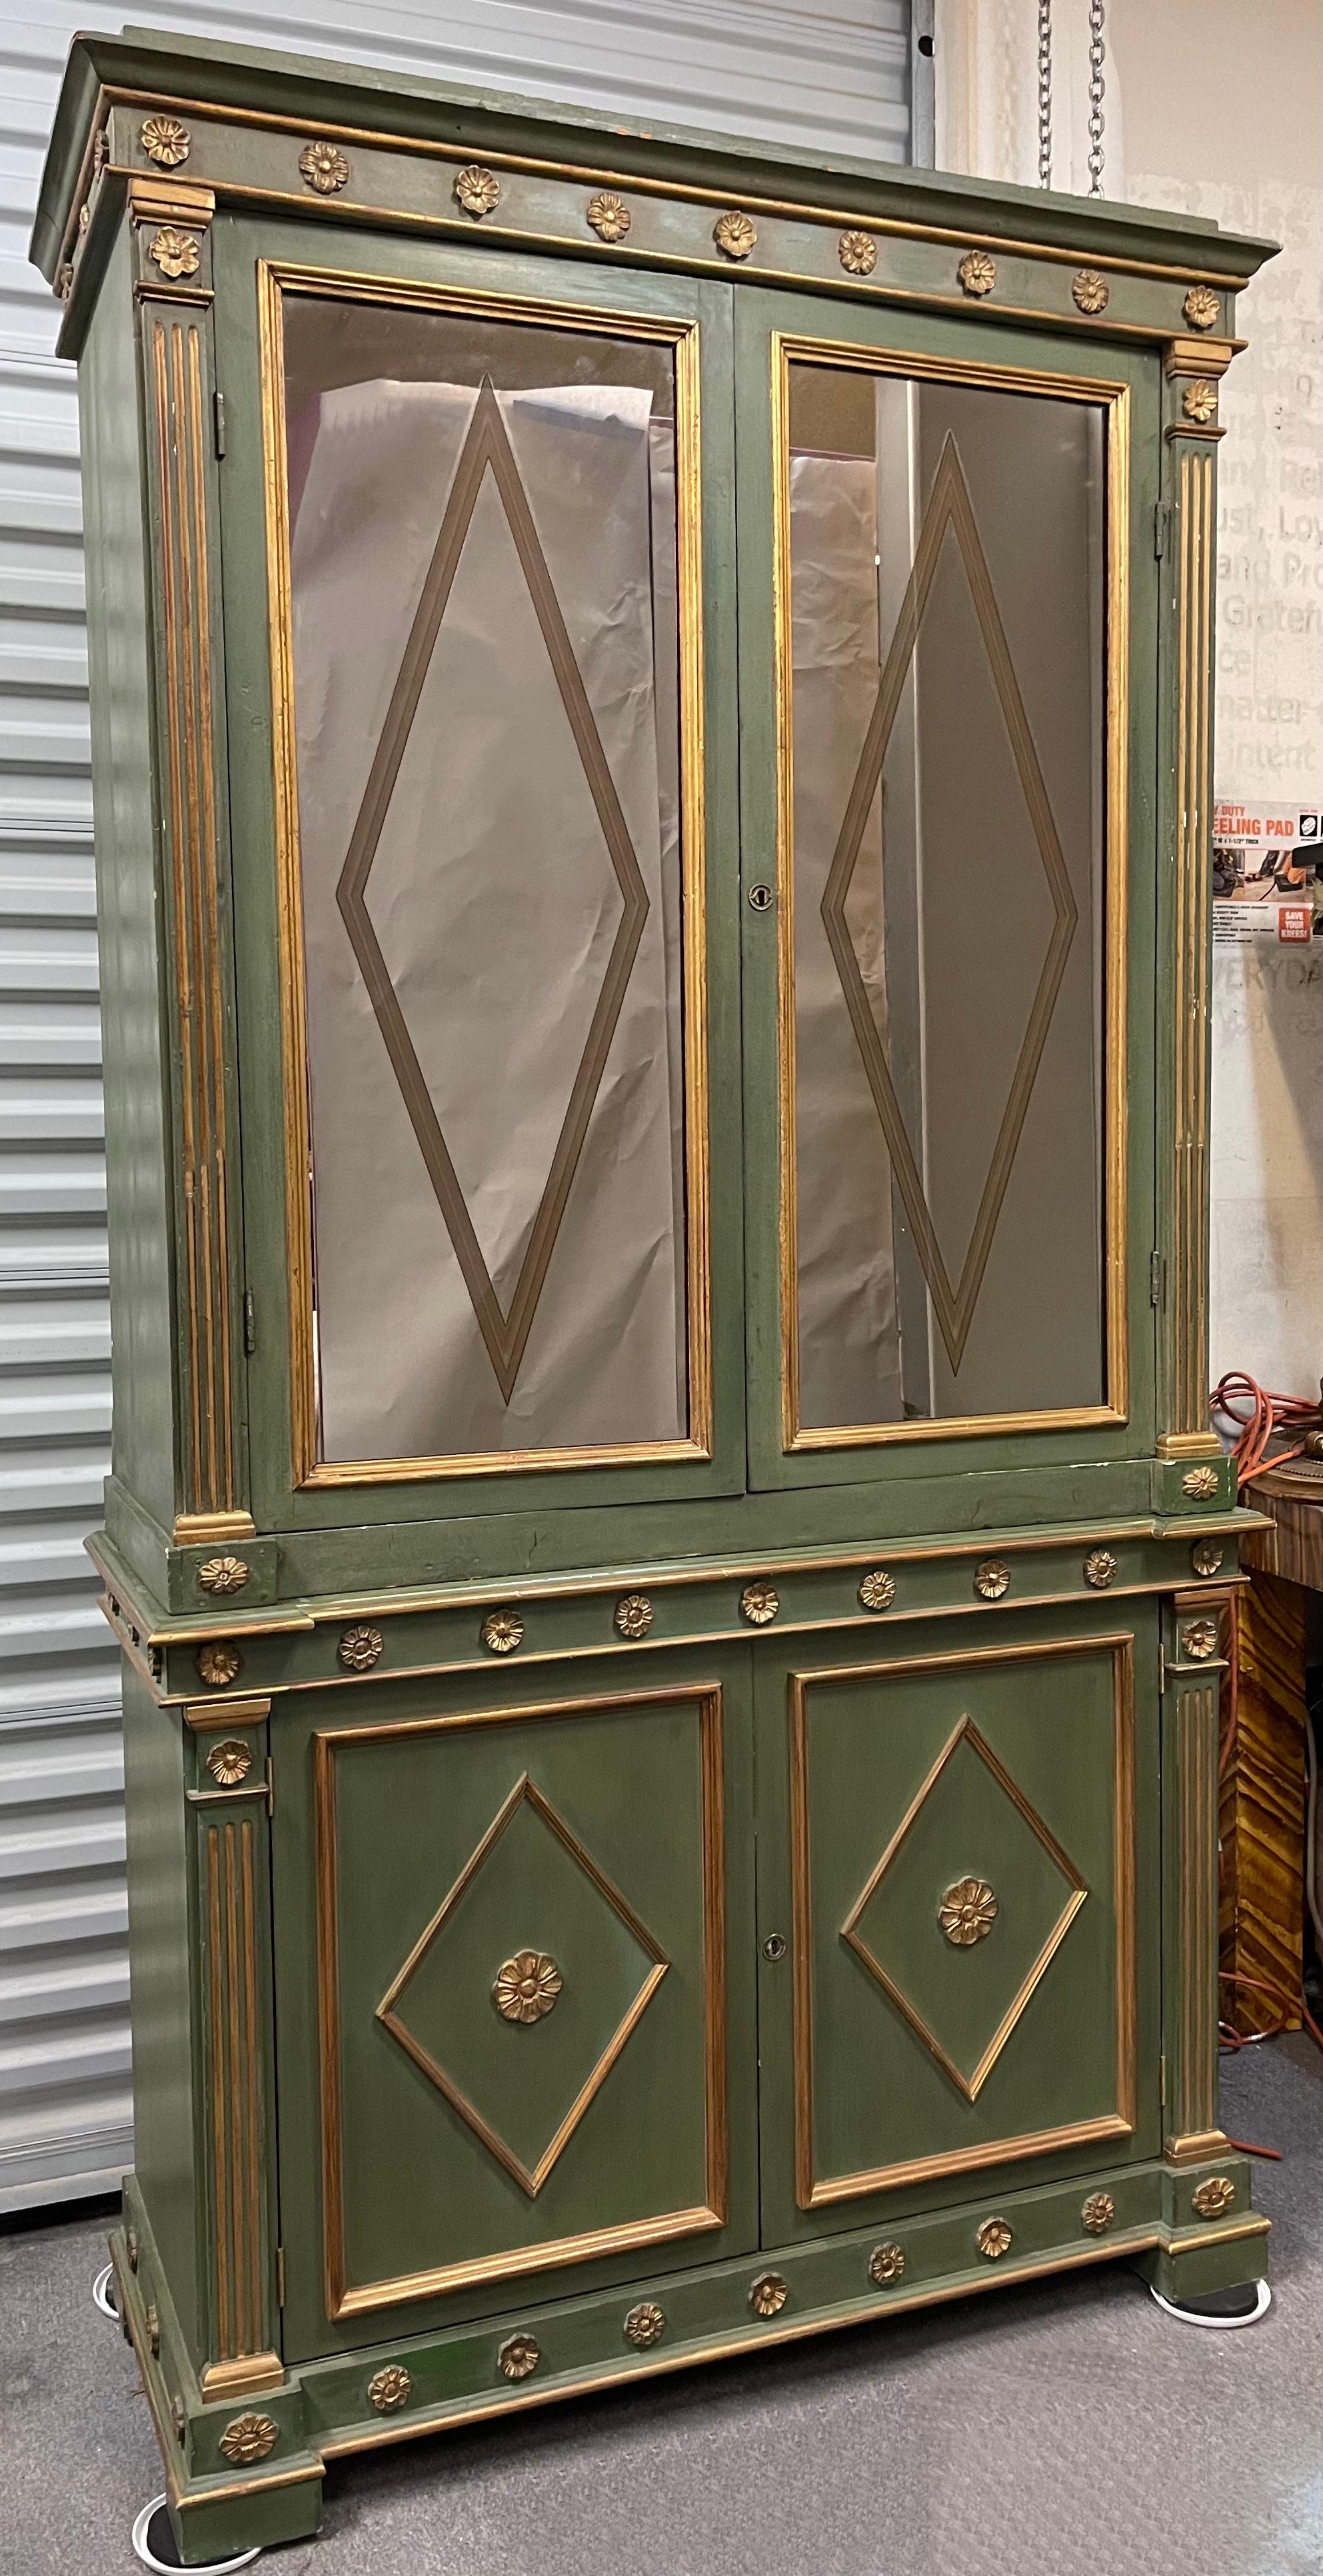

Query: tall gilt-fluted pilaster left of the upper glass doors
[147,312,252,1530]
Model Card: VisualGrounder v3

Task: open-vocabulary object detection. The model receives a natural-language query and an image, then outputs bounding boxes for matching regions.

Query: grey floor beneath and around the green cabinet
[0,2040,1323,2576]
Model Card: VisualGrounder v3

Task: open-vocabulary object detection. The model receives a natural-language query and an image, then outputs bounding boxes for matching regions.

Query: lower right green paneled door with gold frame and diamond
[759,1605,1156,2236]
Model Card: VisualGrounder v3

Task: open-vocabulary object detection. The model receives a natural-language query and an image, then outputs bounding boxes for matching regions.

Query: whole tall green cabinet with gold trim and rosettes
[33,33,1269,2563]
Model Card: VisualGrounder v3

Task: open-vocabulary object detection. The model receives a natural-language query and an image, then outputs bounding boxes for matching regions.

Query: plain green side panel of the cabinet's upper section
[80,227,175,1530]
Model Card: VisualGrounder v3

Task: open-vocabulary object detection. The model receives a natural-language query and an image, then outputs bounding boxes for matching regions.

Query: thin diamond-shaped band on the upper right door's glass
[821,430,1078,1368]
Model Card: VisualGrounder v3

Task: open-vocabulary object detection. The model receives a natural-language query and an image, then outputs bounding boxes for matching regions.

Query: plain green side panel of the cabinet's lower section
[123,1662,201,2355]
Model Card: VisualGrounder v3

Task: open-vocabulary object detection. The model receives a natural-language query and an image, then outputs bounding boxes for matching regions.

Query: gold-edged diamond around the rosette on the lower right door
[842,1716,1089,2102]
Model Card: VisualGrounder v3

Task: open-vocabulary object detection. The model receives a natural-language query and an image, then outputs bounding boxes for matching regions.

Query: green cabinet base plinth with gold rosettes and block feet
[111,2153,1269,2566]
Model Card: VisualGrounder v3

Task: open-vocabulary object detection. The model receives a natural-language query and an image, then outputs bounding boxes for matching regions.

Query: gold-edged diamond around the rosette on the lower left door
[376,1772,669,2200]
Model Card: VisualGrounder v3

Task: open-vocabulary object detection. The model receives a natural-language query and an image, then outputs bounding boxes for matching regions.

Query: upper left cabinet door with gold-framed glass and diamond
[213,242,741,1507]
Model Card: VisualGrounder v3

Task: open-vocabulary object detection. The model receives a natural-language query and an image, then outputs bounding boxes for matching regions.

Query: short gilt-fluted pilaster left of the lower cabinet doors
[203,1816,270,2359]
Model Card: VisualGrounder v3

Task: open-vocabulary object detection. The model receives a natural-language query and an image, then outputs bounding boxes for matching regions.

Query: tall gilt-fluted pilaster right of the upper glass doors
[1158,443,1220,1458]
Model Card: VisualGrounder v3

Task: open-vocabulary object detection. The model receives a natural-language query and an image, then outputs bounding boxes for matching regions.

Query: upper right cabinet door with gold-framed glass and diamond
[738,296,1153,1481]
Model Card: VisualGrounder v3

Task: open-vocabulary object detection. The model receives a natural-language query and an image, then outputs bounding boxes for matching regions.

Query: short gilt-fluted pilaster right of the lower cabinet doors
[1168,1674,1220,2164]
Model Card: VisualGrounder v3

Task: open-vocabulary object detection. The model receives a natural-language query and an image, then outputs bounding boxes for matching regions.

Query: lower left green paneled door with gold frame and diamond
[275,1654,756,2352]
